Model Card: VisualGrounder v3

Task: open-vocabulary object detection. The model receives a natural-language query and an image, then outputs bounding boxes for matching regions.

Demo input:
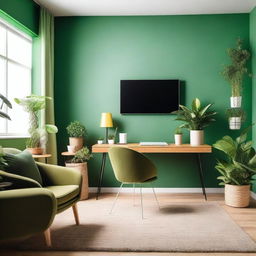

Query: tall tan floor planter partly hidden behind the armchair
[65,163,89,200]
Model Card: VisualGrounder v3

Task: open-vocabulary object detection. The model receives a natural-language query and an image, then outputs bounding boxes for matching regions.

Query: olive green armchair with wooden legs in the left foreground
[0,148,82,246]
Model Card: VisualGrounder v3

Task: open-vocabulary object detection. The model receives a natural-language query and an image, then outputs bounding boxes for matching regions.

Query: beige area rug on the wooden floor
[3,196,256,252]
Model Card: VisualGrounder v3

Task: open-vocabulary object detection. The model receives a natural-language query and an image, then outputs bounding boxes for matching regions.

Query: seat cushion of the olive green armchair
[44,185,80,205]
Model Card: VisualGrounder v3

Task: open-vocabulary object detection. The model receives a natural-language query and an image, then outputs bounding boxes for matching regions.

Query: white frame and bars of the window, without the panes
[0,17,33,139]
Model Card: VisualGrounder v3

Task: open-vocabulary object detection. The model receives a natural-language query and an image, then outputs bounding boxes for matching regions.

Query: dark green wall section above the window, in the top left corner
[0,0,40,35]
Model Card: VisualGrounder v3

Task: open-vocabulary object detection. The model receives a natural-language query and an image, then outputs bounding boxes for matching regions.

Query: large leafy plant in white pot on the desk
[172,98,217,146]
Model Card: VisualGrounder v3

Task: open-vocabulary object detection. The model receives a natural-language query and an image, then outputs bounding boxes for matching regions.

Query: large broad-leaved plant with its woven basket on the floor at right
[213,127,256,207]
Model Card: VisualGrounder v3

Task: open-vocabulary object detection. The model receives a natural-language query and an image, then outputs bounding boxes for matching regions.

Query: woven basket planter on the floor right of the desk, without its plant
[225,184,250,207]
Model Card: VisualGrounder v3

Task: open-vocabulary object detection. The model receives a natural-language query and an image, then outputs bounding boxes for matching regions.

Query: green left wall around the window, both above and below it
[0,0,40,149]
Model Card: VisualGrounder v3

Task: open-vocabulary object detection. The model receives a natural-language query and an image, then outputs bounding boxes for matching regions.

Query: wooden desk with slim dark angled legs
[92,143,212,200]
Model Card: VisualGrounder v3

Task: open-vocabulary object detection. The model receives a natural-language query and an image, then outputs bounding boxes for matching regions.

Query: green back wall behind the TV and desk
[55,14,251,187]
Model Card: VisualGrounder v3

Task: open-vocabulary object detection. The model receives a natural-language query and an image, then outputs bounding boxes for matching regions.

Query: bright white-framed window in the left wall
[0,19,32,137]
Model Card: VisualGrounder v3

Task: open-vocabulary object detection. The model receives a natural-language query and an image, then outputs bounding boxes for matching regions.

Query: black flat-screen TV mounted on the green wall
[120,80,180,114]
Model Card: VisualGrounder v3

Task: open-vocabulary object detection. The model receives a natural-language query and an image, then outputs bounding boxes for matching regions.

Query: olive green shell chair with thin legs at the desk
[108,146,160,219]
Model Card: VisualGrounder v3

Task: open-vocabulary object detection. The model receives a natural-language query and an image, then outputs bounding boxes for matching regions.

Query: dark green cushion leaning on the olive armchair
[4,151,42,185]
